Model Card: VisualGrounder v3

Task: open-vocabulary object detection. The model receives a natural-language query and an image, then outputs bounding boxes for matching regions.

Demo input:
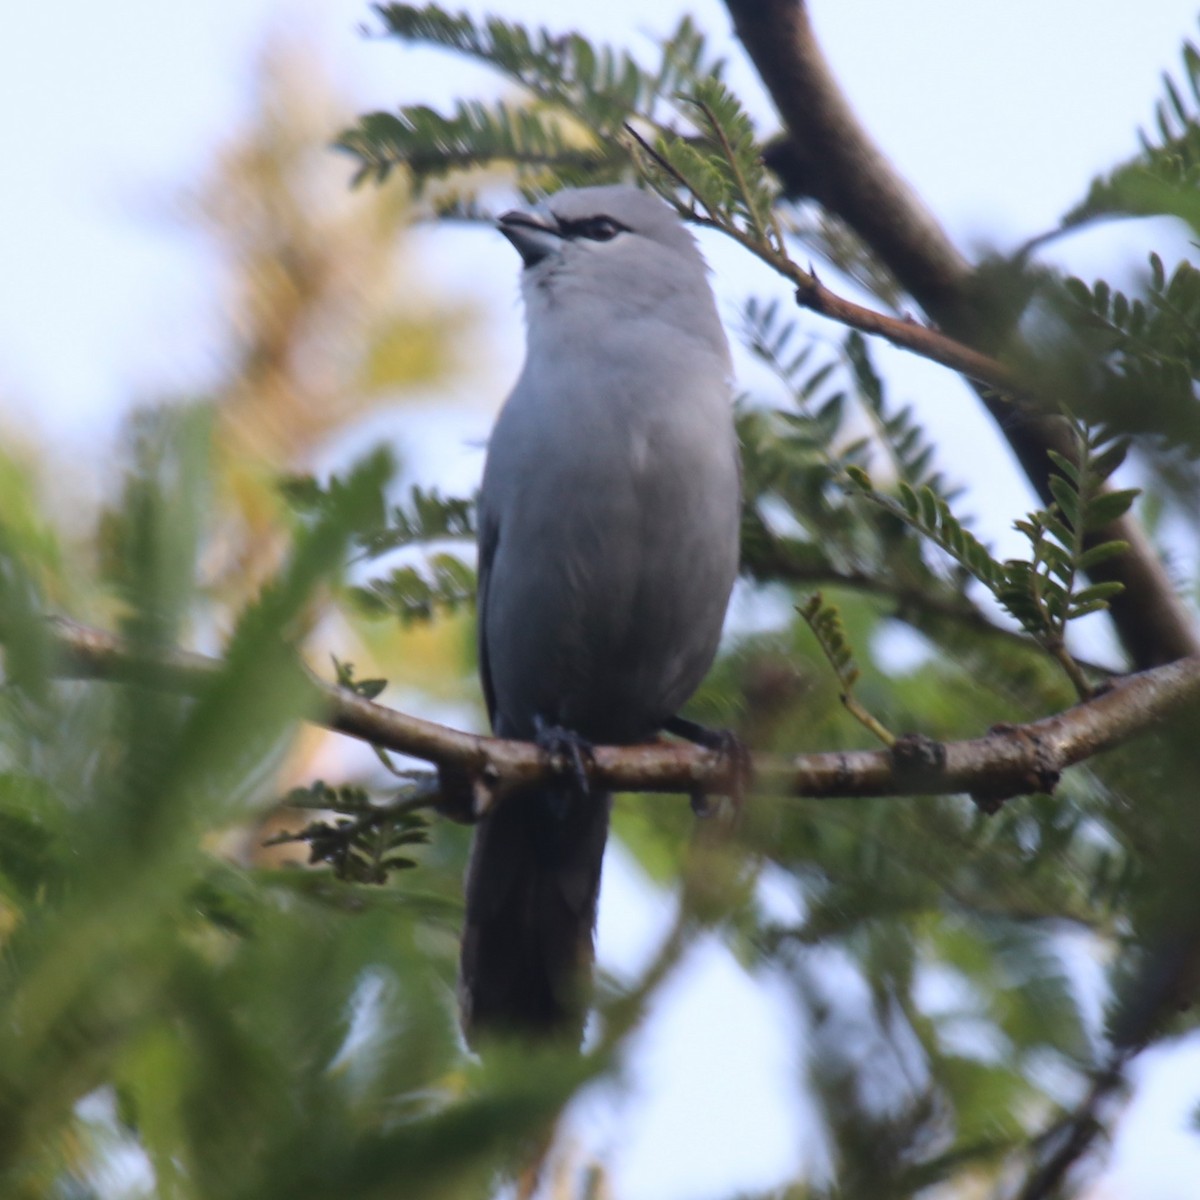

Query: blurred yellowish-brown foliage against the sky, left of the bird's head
[181,42,470,602]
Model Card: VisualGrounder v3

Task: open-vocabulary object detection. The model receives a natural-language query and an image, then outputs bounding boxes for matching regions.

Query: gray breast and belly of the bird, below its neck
[480,336,739,742]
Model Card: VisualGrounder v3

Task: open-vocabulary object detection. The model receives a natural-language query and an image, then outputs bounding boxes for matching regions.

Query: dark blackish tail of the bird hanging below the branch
[458,785,612,1045]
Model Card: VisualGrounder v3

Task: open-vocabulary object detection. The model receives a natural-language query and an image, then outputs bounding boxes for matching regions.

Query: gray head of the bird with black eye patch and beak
[498,185,724,341]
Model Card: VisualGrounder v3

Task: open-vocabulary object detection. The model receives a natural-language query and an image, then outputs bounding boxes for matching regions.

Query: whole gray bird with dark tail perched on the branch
[460,186,740,1043]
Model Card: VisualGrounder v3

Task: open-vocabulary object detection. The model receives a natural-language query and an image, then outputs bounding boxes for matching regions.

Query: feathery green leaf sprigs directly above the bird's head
[338,5,785,265]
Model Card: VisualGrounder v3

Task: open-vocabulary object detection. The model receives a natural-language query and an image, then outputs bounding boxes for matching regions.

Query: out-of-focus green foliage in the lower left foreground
[0,410,596,1200]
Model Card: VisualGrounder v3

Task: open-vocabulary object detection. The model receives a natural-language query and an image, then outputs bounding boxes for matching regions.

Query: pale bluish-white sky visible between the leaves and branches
[0,0,1200,1200]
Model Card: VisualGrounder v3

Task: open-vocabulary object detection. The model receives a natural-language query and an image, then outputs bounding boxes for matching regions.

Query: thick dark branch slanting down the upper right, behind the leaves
[725,0,1200,667]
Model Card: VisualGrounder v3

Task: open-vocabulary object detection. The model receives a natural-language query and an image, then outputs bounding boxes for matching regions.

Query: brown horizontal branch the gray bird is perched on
[42,620,1200,810]
